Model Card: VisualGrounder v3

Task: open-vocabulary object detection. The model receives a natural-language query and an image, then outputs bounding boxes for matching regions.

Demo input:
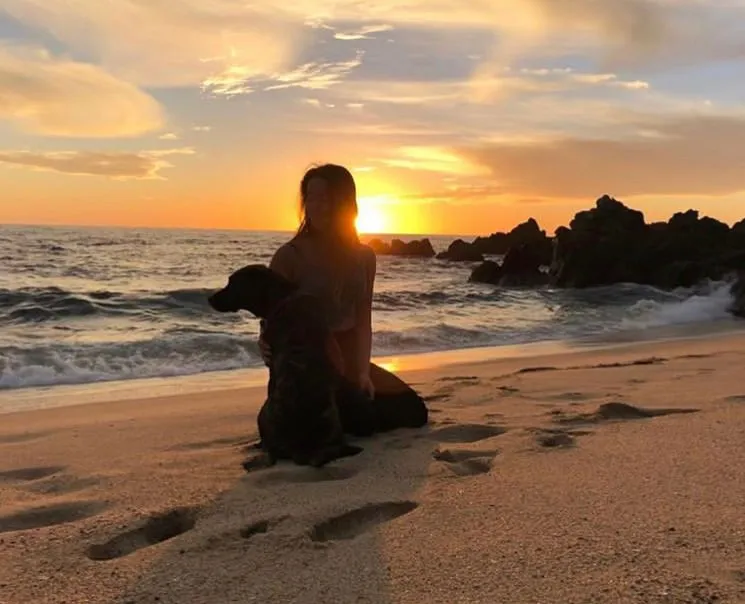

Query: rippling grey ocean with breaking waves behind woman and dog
[0,226,731,390]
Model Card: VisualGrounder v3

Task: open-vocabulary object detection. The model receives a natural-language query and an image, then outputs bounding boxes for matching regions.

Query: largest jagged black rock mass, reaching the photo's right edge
[549,195,745,288]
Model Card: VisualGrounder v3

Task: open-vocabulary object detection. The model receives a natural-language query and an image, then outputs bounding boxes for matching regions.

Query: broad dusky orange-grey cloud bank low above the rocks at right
[460,115,745,199]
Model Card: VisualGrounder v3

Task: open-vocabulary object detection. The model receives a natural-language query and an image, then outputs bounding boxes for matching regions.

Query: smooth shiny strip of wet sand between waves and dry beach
[0,319,745,416]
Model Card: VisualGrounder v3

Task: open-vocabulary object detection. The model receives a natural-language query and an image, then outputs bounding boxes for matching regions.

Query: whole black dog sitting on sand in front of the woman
[209,264,362,467]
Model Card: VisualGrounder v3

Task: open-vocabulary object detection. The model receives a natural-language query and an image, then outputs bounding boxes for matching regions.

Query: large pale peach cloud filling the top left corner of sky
[3,0,310,87]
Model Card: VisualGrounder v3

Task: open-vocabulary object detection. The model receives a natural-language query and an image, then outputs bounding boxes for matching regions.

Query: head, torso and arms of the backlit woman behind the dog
[259,164,376,398]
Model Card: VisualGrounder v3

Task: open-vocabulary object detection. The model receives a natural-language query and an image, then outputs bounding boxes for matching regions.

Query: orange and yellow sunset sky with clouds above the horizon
[0,0,745,234]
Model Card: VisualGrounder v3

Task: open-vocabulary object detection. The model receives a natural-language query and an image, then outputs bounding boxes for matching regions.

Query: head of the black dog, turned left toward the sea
[208,264,295,319]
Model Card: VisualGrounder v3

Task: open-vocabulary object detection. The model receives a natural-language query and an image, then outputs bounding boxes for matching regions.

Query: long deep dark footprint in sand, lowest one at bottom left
[86,508,196,560]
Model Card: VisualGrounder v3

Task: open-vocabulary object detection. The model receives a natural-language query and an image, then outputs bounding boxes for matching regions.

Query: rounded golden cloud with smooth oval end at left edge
[0,46,163,138]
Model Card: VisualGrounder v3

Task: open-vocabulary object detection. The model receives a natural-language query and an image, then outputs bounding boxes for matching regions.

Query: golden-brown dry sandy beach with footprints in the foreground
[0,334,745,604]
